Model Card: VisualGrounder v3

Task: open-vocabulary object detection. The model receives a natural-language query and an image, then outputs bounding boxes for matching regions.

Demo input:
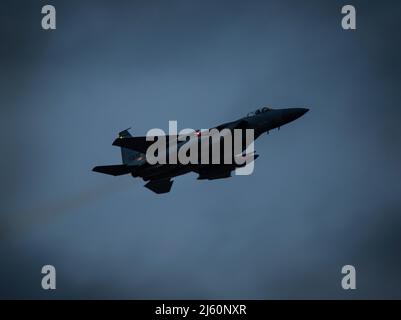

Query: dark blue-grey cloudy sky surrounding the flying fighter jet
[0,0,401,299]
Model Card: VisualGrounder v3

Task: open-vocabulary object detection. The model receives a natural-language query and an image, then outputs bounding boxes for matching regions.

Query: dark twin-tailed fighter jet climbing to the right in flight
[92,107,309,194]
